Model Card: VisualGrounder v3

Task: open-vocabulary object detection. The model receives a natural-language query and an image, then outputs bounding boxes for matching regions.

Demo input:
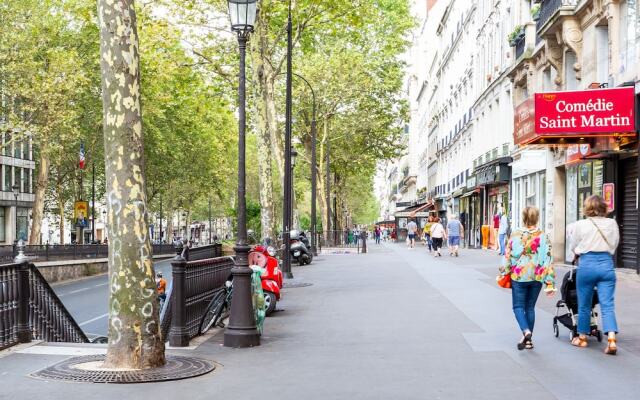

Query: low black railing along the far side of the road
[0,244,192,263]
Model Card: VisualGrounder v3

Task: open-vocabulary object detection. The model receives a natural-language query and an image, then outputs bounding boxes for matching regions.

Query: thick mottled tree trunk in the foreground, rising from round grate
[98,0,165,369]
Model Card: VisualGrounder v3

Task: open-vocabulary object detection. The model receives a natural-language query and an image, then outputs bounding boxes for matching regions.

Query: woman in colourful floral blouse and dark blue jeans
[501,207,556,350]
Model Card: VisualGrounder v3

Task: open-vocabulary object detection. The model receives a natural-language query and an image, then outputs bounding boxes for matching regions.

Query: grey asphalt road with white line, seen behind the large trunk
[53,259,171,338]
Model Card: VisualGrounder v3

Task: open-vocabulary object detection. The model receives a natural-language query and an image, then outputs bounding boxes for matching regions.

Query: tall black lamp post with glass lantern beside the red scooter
[224,0,260,347]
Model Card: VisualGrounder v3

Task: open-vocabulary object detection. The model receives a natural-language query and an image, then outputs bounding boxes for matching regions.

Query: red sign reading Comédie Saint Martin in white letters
[535,87,635,135]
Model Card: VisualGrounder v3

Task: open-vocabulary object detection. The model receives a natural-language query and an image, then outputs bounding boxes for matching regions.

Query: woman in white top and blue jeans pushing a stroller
[571,196,620,355]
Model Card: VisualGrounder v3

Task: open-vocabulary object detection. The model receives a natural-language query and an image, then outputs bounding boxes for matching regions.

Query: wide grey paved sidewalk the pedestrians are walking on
[0,244,640,400]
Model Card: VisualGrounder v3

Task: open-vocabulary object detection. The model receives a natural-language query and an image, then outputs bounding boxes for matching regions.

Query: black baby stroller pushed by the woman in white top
[553,268,602,342]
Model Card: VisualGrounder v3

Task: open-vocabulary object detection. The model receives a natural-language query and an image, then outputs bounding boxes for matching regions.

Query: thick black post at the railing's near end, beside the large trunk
[169,242,189,347]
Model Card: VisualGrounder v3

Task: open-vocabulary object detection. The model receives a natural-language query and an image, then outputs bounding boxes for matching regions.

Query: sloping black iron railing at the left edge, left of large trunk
[0,262,89,349]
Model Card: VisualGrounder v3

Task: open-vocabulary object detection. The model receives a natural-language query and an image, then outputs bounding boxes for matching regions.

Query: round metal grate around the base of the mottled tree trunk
[31,354,215,383]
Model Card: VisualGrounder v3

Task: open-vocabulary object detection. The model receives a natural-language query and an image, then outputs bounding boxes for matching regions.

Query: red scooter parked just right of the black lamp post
[249,241,282,315]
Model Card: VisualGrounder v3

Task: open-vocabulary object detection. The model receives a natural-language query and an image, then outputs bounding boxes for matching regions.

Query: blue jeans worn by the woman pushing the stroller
[576,252,618,335]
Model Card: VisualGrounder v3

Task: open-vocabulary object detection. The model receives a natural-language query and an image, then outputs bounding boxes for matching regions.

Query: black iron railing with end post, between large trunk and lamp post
[160,245,234,347]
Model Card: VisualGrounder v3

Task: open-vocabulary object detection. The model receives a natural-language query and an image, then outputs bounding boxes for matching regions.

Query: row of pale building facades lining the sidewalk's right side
[381,0,640,268]
